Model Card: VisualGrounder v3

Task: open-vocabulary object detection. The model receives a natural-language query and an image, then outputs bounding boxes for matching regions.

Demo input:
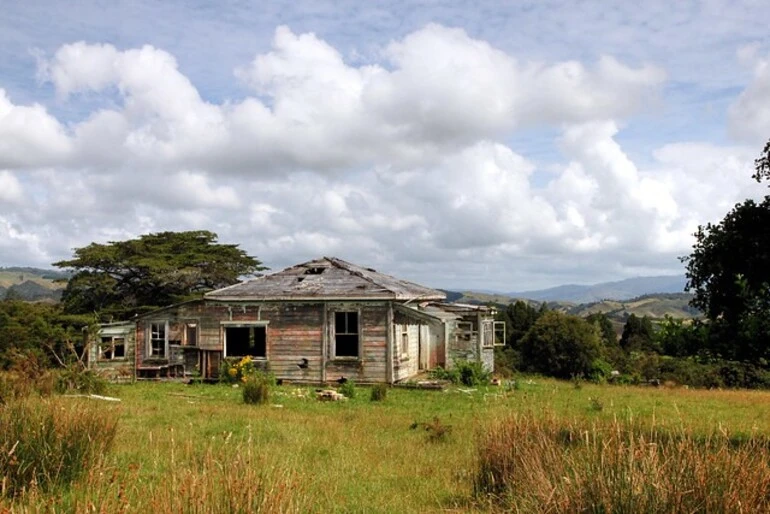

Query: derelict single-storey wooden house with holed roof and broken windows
[89,257,503,383]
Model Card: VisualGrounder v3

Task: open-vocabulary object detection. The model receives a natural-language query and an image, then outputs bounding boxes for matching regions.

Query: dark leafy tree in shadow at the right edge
[682,142,770,365]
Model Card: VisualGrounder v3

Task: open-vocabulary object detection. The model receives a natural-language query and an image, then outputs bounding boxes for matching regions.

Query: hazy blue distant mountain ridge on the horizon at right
[506,275,687,303]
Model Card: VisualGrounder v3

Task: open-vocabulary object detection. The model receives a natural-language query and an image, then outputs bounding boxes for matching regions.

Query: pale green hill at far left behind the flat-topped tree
[0,267,69,302]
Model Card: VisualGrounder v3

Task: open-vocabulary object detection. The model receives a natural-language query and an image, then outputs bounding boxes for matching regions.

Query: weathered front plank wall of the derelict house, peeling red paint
[136,300,389,383]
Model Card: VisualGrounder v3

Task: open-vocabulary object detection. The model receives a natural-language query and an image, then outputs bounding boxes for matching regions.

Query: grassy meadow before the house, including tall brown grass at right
[0,377,770,513]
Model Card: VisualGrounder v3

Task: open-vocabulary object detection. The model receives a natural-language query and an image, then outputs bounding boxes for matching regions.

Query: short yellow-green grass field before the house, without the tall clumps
[0,377,770,512]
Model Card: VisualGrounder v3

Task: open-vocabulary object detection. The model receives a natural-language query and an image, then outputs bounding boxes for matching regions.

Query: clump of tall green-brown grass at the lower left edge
[0,397,117,497]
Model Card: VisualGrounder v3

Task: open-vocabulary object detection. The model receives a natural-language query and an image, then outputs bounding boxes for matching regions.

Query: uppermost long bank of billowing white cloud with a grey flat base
[22,25,664,175]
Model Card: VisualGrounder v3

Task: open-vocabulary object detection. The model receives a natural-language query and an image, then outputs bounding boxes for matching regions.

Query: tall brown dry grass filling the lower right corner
[474,414,770,513]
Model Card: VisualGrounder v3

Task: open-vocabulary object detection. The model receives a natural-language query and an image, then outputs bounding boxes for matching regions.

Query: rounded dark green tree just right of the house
[521,311,601,378]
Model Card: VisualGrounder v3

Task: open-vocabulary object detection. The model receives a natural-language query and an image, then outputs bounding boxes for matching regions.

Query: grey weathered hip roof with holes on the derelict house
[204,257,446,301]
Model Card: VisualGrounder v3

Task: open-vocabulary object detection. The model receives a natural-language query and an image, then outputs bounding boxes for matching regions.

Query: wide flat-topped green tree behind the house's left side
[54,230,267,316]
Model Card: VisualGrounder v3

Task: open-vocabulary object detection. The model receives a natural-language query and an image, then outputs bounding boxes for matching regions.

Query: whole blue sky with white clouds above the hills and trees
[0,0,770,291]
